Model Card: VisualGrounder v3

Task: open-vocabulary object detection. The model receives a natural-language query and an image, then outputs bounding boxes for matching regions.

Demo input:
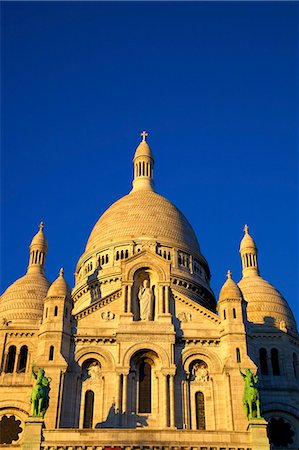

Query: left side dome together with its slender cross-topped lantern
[0,223,51,324]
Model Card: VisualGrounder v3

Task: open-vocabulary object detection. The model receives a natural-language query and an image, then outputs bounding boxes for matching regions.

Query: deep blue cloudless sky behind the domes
[1,2,298,320]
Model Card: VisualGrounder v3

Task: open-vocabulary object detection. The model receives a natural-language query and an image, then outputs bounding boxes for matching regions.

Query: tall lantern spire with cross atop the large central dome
[132,131,154,191]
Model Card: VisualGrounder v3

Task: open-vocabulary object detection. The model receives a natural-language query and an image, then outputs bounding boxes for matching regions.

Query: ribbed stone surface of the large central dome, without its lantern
[86,190,200,254]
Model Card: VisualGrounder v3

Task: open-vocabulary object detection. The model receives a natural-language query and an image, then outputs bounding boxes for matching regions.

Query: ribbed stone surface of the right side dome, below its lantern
[238,275,297,330]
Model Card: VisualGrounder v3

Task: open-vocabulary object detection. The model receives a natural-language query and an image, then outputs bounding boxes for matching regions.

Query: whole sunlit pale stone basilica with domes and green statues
[0,132,299,450]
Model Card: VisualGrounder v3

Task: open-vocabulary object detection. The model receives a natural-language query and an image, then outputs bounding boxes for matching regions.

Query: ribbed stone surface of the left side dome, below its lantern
[0,272,50,322]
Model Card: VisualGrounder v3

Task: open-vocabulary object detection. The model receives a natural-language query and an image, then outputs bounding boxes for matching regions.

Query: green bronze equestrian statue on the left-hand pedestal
[30,363,52,418]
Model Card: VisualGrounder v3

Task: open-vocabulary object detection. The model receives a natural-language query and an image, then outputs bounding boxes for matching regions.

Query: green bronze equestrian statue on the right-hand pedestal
[239,367,261,420]
